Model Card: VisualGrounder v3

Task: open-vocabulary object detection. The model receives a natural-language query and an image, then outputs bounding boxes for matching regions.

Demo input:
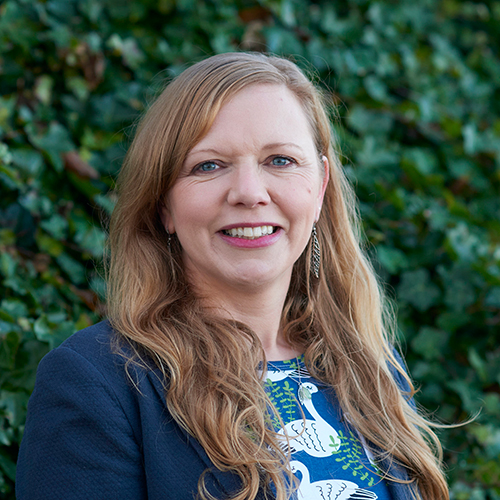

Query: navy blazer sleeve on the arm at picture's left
[16,346,147,500]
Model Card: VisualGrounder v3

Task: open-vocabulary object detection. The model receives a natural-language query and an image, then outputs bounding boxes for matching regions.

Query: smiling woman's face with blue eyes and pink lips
[162,85,328,298]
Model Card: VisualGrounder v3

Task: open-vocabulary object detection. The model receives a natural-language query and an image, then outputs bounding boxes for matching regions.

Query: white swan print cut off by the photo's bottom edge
[290,460,378,500]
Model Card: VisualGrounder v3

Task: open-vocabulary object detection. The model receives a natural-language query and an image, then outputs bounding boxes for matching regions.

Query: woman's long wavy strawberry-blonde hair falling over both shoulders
[108,53,449,500]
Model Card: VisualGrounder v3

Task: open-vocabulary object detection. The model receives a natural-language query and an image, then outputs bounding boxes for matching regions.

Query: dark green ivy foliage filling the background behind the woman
[0,0,500,500]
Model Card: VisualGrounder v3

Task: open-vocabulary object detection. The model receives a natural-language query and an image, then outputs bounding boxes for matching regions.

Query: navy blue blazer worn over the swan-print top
[16,321,411,500]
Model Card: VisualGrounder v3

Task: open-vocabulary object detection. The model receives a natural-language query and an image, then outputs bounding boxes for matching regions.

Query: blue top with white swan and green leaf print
[264,357,391,500]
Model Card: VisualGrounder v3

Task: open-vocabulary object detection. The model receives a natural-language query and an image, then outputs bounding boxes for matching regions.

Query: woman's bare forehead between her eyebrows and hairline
[192,84,315,153]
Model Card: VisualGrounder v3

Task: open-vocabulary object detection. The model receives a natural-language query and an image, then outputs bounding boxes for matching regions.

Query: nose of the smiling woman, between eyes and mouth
[227,164,271,208]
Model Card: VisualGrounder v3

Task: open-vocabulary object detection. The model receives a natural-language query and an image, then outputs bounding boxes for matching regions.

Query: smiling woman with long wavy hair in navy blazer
[17,53,448,500]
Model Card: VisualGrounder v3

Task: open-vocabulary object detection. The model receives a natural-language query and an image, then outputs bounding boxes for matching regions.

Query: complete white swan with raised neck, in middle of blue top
[278,382,341,458]
